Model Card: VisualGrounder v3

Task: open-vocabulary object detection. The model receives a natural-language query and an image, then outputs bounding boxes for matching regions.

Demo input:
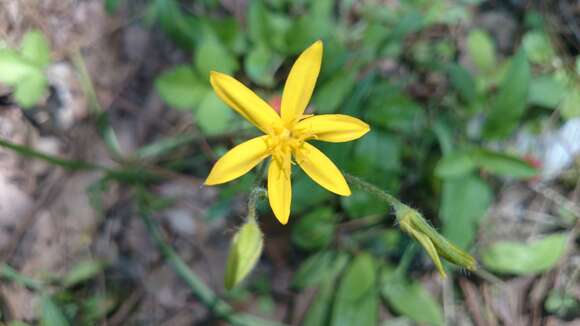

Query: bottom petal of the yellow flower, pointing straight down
[268,154,292,224]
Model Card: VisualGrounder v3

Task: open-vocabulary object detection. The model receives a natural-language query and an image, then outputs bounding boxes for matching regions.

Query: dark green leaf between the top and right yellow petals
[312,70,356,114]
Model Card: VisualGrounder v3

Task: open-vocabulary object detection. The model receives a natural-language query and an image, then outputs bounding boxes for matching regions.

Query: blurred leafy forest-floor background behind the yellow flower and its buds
[0,0,580,326]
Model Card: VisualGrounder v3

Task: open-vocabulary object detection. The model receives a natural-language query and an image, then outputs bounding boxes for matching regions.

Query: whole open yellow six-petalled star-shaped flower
[205,41,369,224]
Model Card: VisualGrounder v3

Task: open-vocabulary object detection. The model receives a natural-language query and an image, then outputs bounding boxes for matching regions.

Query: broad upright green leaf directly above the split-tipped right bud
[439,175,492,249]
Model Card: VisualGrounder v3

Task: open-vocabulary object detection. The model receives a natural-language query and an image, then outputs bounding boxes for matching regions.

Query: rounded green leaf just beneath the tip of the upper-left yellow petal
[195,92,233,135]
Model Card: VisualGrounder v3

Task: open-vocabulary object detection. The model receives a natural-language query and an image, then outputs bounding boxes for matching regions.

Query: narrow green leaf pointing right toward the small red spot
[472,149,538,179]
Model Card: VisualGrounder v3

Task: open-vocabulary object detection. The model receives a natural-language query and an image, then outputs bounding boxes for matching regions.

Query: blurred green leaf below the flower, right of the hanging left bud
[292,251,348,289]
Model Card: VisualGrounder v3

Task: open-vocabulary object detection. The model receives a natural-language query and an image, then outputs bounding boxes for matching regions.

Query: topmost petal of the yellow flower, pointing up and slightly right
[281,41,322,126]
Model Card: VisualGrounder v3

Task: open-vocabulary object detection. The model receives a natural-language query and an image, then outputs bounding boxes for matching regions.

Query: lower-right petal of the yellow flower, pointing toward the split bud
[294,143,350,196]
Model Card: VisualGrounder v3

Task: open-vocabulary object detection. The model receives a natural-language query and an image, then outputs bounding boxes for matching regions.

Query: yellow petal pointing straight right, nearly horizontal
[294,114,370,143]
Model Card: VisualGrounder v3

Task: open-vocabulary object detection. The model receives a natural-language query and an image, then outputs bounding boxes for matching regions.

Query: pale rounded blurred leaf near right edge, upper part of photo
[528,75,566,108]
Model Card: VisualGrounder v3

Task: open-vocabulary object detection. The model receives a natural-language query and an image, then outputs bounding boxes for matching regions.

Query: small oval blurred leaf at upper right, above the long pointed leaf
[467,29,496,72]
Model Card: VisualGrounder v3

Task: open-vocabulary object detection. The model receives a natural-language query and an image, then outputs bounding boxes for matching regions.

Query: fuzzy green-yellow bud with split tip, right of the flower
[396,205,477,277]
